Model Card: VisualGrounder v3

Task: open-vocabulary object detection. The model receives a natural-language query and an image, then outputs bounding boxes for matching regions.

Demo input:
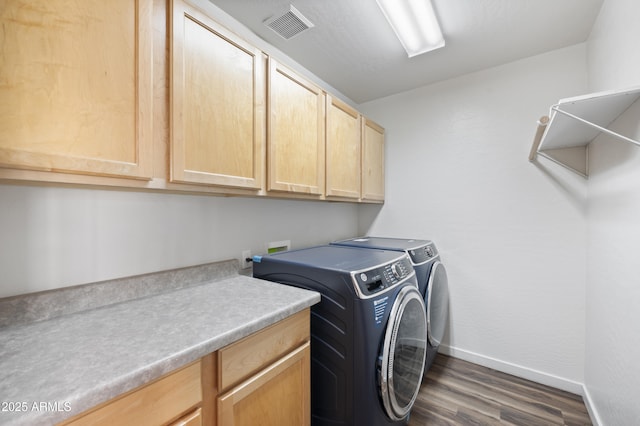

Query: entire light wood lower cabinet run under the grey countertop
[61,309,311,426]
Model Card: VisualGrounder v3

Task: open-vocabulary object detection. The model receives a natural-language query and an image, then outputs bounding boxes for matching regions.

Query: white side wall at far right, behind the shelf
[585,0,640,425]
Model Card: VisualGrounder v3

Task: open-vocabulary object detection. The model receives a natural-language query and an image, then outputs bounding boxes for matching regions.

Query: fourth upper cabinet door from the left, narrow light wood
[326,95,361,200]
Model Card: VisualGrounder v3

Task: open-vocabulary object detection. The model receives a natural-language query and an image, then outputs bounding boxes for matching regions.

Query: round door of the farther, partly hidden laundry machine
[425,261,449,347]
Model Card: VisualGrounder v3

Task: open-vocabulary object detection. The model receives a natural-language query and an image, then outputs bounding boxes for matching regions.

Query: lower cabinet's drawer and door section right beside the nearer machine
[217,309,311,426]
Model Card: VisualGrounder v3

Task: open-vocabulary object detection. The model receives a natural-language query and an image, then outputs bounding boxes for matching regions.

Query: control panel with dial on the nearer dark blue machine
[352,256,415,298]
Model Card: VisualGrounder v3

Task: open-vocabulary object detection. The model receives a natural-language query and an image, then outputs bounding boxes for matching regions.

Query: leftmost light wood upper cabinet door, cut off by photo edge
[0,0,153,179]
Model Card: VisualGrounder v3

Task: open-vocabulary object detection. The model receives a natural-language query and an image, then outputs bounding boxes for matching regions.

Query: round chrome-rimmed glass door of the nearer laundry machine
[379,286,427,420]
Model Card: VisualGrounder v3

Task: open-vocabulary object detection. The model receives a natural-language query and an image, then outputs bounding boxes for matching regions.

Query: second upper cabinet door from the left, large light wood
[171,0,266,189]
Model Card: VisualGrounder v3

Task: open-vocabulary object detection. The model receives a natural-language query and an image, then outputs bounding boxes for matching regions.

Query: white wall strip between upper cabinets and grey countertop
[0,185,358,297]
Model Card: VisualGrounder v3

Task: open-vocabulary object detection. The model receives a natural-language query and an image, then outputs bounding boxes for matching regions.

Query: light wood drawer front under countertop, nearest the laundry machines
[218,309,310,391]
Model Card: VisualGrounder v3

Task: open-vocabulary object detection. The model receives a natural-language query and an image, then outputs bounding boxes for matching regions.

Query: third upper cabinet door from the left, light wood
[267,58,325,196]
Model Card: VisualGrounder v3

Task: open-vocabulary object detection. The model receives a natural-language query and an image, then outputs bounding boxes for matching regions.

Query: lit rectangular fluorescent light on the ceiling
[376,0,444,58]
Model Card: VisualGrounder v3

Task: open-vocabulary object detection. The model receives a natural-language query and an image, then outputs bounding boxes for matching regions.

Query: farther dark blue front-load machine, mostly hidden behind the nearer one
[331,237,449,372]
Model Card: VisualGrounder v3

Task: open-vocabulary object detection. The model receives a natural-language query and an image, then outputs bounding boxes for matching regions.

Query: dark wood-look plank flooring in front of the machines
[409,354,591,426]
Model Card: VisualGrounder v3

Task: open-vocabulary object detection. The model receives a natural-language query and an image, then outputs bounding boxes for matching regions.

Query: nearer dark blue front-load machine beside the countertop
[253,245,427,426]
